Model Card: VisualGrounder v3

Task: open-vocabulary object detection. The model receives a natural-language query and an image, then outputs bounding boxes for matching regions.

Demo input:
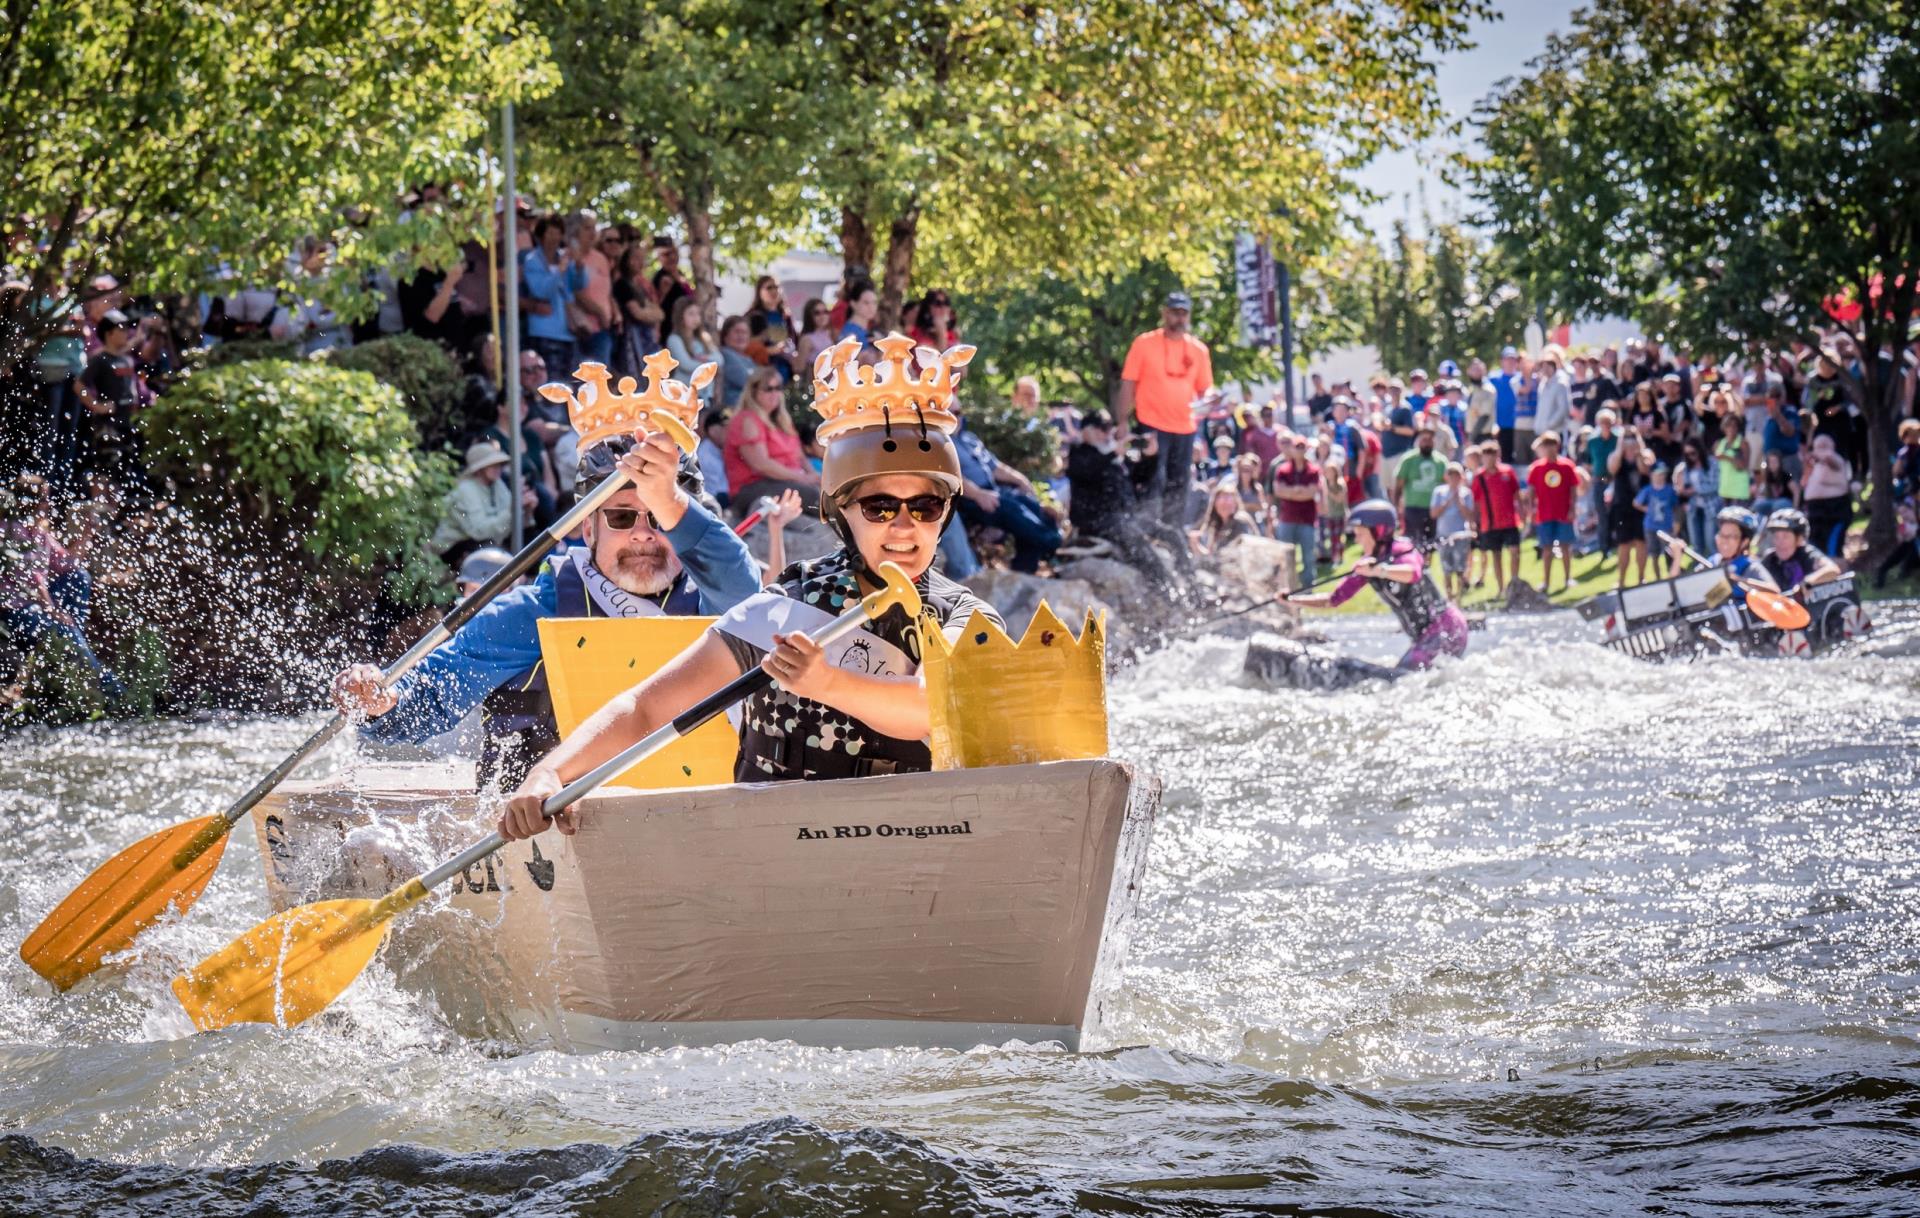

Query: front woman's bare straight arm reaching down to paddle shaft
[497,630,739,841]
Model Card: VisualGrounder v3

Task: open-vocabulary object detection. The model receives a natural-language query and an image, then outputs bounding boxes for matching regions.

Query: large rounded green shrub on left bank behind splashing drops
[132,359,453,705]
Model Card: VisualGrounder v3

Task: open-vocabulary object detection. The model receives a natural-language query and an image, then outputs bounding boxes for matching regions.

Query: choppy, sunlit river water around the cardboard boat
[0,607,1920,1218]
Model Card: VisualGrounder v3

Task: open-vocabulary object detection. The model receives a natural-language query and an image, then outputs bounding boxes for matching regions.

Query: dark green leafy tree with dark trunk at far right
[1469,0,1920,561]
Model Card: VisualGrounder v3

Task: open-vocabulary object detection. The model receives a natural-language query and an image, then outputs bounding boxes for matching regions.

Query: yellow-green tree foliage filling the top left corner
[0,0,547,363]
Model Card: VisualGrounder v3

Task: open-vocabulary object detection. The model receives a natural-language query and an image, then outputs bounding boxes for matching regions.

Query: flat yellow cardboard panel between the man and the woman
[540,617,739,790]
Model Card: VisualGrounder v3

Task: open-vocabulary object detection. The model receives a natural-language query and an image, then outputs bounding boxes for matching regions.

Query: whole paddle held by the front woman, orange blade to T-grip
[173,563,920,1032]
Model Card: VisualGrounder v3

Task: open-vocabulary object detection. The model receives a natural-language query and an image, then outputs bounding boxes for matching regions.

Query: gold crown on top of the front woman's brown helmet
[814,334,975,444]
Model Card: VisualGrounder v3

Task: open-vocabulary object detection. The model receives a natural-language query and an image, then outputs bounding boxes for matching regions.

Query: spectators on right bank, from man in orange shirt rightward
[1094,330,1920,596]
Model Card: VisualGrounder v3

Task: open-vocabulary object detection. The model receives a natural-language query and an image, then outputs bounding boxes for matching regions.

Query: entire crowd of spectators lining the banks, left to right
[0,190,1920,703]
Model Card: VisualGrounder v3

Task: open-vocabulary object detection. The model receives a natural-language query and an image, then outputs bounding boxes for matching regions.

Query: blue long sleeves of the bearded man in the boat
[361,501,760,743]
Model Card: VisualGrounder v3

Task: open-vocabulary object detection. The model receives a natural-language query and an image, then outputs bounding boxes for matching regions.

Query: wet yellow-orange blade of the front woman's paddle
[173,880,426,1032]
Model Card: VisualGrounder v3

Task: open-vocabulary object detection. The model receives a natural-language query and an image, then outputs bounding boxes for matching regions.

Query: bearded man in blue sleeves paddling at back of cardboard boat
[334,432,760,790]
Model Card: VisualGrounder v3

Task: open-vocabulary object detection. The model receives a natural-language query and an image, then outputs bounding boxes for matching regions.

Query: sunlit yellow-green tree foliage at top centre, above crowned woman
[806,0,1490,325]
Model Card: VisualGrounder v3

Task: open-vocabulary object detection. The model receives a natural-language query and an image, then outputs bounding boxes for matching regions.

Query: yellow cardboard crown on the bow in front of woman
[920,601,1106,770]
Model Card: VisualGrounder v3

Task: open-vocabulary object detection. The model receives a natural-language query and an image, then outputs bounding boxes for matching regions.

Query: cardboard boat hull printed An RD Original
[253,759,1160,1049]
